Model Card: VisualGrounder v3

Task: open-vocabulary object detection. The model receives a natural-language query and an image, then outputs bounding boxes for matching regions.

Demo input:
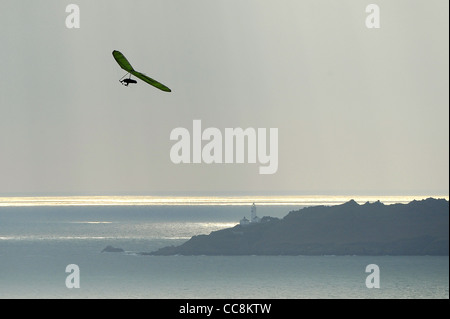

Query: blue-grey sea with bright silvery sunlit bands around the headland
[0,196,449,299]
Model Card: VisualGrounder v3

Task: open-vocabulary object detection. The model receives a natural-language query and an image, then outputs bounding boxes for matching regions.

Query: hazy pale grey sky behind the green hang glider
[0,0,449,195]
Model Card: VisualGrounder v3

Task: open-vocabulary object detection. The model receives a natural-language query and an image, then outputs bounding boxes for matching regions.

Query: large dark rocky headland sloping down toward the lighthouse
[146,198,449,255]
